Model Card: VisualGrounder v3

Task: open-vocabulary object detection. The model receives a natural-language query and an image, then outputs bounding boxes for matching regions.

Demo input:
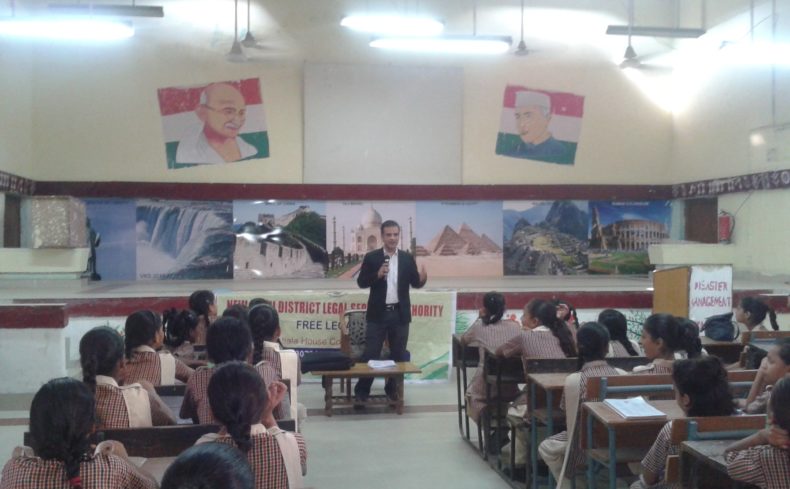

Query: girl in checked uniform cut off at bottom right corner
[724,378,790,489]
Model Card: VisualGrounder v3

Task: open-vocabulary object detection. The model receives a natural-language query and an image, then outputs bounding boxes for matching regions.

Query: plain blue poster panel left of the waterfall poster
[85,199,137,280]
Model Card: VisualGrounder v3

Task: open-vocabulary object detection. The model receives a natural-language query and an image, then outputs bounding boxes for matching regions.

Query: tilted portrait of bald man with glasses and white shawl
[158,78,269,169]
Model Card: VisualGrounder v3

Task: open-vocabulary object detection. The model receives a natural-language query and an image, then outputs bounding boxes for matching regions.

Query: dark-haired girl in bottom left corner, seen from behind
[0,377,157,489]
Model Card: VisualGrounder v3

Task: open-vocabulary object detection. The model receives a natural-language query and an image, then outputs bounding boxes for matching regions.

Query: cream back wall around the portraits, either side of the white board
[18,42,672,184]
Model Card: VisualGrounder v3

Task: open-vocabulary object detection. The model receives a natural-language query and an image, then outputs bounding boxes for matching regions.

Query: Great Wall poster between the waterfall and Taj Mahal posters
[233,200,329,280]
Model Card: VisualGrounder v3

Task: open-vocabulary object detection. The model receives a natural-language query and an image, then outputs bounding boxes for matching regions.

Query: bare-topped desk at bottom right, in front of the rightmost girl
[680,440,754,488]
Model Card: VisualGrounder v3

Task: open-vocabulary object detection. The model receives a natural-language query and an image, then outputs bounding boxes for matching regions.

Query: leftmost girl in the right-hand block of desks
[461,292,521,423]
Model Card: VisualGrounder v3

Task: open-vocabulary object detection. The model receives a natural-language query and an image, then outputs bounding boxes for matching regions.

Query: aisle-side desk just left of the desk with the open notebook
[527,372,571,489]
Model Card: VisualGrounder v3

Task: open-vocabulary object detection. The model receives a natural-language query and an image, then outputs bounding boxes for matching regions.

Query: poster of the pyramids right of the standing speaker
[414,201,502,277]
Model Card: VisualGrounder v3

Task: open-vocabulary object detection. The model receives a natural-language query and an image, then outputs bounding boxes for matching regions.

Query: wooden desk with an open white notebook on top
[581,400,685,489]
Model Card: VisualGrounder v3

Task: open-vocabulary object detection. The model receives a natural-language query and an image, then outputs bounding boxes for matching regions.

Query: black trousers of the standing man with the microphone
[354,309,409,396]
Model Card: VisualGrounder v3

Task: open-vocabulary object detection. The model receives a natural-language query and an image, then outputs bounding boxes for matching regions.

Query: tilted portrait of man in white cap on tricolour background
[496,85,584,165]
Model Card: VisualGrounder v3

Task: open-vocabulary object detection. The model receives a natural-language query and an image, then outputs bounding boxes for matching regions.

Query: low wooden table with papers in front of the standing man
[310,362,422,416]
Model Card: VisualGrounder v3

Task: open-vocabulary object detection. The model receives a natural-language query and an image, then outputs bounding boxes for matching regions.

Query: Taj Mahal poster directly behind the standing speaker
[326,201,418,280]
